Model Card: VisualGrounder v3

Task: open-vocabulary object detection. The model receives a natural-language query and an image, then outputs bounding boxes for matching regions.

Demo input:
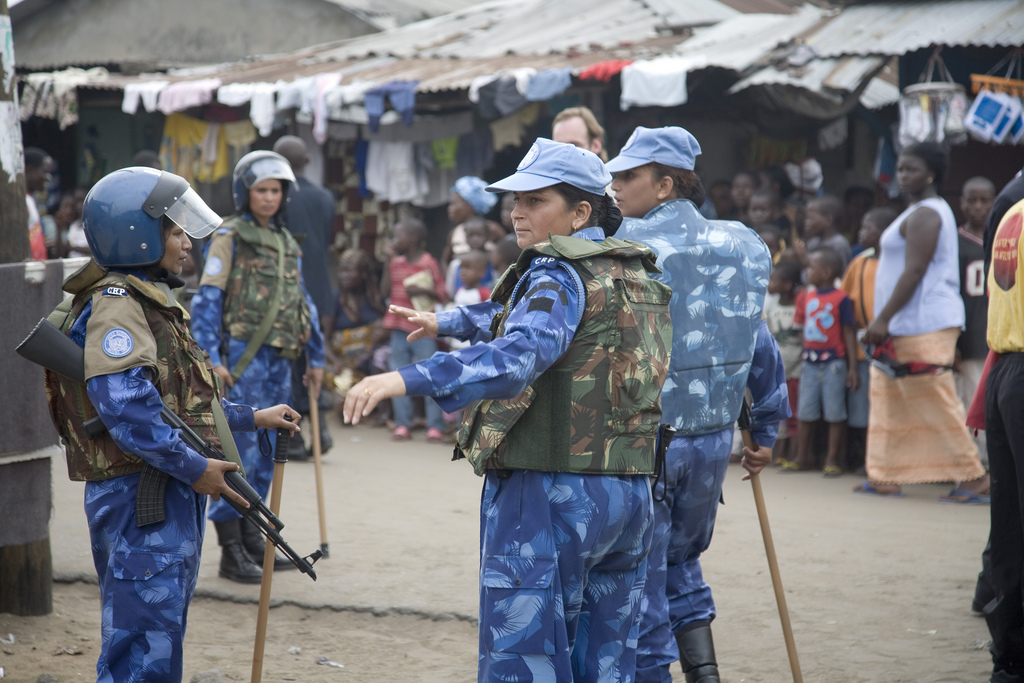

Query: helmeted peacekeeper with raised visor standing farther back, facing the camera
[191,152,325,584]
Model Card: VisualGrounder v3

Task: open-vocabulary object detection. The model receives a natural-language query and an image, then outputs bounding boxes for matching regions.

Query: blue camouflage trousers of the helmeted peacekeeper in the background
[209,339,292,522]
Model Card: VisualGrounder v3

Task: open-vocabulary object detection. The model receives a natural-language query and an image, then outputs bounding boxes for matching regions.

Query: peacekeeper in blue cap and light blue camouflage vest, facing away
[606,127,790,683]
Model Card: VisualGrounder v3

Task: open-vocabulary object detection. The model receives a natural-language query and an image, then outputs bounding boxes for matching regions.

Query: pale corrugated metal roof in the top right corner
[807,0,1024,57]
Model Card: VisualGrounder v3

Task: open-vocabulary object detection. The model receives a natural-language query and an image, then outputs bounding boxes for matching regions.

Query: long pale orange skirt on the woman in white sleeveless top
[866,328,985,484]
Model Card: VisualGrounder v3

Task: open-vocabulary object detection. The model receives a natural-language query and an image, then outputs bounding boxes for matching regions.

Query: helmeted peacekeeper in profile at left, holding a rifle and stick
[46,167,298,683]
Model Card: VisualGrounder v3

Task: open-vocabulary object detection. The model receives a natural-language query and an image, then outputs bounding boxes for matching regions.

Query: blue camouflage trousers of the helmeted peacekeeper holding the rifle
[85,474,206,683]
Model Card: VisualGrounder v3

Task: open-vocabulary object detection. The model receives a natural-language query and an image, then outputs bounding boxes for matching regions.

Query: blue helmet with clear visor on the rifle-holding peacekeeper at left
[82,166,221,268]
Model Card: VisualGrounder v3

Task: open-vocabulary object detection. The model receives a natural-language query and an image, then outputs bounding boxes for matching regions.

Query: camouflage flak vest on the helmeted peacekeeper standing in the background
[222,216,312,352]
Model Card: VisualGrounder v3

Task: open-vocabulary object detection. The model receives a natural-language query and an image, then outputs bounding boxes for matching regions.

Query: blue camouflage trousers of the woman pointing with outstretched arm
[478,470,652,683]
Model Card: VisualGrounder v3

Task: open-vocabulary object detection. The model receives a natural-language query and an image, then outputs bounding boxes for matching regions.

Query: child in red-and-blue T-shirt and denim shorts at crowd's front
[786,248,859,476]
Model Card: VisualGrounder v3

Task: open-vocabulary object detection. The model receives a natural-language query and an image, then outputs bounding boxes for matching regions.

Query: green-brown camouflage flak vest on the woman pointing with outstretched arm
[459,237,672,474]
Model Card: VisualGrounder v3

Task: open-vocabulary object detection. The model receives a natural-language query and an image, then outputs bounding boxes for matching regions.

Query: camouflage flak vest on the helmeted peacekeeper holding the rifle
[45,272,220,481]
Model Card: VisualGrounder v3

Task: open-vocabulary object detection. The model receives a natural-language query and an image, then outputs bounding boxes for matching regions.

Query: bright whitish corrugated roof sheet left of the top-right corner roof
[675,5,824,73]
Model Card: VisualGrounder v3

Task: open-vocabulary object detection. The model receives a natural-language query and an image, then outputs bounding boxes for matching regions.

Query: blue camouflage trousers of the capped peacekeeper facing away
[637,428,732,683]
